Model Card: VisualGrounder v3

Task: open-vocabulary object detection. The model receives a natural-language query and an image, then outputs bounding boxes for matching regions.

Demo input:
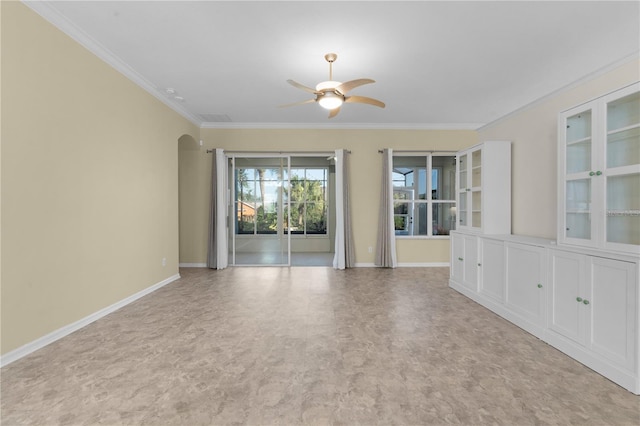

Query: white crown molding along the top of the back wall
[200,122,484,130]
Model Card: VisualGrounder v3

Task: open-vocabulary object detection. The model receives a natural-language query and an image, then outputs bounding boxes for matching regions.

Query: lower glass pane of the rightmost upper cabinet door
[607,173,640,244]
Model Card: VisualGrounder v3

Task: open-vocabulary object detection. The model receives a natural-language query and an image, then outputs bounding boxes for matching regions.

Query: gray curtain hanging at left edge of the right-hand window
[375,149,398,268]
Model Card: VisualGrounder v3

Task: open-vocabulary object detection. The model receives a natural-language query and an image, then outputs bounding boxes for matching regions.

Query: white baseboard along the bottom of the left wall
[0,274,180,367]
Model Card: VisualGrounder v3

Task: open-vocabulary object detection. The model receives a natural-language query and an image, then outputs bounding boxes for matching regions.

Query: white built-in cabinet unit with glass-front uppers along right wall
[449,83,640,394]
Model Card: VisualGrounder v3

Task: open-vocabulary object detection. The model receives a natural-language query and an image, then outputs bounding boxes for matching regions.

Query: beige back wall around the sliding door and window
[180,129,477,264]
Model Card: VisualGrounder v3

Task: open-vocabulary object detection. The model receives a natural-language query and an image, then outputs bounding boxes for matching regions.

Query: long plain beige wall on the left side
[1,1,199,354]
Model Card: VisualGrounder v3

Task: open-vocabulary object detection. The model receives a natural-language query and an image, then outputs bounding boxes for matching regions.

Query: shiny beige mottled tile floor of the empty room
[0,267,640,425]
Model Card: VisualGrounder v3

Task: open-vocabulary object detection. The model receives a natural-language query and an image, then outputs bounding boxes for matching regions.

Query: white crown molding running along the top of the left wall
[22,0,202,126]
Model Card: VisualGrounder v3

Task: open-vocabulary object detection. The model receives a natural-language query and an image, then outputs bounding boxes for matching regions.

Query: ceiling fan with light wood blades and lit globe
[281,53,384,118]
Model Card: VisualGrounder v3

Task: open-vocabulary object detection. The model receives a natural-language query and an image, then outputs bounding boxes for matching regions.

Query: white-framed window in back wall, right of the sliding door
[392,154,456,237]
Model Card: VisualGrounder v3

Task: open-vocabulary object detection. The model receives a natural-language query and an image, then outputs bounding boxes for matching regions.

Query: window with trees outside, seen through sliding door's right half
[284,167,329,235]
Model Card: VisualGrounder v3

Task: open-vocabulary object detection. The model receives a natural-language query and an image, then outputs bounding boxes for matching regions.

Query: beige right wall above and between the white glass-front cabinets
[478,59,640,239]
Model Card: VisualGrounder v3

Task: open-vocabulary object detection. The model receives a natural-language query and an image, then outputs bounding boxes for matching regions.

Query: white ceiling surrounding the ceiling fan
[27,1,640,128]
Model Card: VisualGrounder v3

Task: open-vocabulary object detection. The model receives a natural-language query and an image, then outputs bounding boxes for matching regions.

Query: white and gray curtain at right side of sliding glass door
[333,149,355,269]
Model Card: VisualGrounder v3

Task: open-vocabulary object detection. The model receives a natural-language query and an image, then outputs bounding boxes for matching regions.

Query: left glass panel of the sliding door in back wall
[229,156,291,266]
